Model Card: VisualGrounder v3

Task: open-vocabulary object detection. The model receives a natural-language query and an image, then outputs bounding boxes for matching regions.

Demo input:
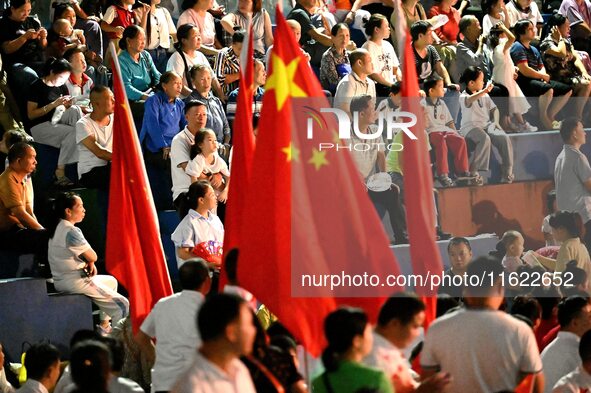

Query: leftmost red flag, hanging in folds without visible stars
[105,44,172,332]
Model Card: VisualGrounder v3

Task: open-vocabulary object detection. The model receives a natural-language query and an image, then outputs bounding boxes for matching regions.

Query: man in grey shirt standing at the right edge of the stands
[554,117,591,249]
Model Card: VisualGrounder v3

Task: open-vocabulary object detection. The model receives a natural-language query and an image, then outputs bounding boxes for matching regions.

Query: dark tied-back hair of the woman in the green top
[322,307,368,372]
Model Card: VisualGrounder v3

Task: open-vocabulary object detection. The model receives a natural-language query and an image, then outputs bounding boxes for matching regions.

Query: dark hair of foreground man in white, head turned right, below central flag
[197,293,246,342]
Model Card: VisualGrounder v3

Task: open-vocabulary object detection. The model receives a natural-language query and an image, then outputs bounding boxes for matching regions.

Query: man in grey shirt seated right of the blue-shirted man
[186,64,231,146]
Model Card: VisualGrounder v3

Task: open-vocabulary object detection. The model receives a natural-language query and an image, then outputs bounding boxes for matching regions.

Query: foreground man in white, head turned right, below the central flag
[172,294,256,393]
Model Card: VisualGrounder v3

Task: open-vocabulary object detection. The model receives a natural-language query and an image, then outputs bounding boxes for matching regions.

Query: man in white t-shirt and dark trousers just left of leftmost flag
[76,86,115,190]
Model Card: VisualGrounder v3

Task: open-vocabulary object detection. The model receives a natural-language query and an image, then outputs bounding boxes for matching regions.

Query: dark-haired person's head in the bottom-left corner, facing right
[17,344,60,393]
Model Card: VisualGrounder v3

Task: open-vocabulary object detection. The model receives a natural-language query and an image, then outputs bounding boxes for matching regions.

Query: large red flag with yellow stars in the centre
[238,10,399,355]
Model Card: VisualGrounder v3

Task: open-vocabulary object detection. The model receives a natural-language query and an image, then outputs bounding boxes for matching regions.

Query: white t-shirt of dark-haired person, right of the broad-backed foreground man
[541,331,581,393]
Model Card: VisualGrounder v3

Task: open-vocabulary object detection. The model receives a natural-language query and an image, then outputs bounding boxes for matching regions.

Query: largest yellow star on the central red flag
[265,54,308,111]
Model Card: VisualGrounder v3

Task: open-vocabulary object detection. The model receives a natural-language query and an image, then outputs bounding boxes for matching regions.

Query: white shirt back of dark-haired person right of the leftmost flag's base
[140,290,204,392]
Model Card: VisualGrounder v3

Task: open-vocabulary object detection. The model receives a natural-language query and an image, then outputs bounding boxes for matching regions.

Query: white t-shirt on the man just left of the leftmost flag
[76,115,113,177]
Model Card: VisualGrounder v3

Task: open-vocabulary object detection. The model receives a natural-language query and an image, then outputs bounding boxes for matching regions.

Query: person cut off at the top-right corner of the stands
[558,0,591,54]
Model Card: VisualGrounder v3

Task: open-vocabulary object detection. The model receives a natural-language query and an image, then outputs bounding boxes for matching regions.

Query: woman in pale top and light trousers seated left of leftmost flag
[48,192,129,333]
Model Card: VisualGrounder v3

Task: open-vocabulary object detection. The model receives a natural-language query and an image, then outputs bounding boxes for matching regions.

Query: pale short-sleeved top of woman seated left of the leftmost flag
[47,220,92,281]
